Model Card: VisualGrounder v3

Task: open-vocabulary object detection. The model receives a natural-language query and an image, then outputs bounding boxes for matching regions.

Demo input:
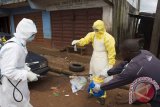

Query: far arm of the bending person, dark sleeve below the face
[107,61,128,76]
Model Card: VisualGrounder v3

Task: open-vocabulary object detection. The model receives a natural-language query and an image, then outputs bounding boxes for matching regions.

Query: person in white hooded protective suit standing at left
[0,18,38,107]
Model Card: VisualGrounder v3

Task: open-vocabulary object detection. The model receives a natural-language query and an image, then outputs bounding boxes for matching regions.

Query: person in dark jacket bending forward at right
[90,39,160,107]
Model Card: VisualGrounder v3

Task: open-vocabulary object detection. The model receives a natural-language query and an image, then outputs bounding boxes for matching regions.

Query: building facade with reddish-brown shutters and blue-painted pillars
[0,0,138,51]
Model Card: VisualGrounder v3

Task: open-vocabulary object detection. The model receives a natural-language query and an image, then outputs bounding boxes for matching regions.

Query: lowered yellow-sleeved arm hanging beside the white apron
[104,33,116,66]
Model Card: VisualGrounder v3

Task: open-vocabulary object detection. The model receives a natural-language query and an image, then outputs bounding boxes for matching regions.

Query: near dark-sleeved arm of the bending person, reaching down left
[101,62,141,90]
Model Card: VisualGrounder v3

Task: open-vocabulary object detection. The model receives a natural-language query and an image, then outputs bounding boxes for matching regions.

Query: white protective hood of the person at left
[14,18,37,45]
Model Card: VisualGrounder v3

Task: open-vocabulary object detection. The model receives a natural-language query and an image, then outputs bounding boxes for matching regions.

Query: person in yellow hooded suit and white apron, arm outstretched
[72,20,116,105]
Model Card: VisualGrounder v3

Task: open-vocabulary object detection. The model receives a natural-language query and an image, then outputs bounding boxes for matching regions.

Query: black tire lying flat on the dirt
[69,63,84,72]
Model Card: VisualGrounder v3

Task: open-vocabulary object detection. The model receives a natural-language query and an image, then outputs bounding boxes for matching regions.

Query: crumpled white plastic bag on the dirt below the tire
[70,76,87,93]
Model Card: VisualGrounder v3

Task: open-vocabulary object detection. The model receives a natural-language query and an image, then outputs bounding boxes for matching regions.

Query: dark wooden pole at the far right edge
[150,0,160,56]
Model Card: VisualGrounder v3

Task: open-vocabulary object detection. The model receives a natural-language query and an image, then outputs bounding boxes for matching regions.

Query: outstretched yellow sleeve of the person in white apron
[77,32,94,46]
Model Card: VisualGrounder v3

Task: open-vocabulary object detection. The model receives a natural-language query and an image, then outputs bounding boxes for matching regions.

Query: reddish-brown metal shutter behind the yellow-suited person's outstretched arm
[51,8,102,47]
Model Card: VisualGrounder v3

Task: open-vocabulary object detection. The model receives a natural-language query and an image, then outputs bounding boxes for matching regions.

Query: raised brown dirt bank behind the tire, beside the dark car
[29,46,91,74]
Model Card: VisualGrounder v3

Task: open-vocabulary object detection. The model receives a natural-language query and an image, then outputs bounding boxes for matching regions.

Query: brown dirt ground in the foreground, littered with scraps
[29,73,150,107]
